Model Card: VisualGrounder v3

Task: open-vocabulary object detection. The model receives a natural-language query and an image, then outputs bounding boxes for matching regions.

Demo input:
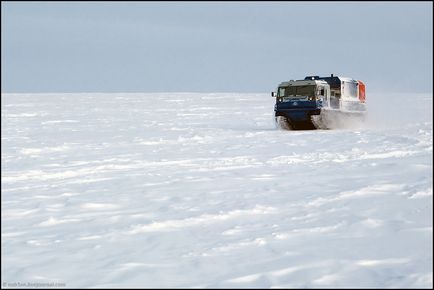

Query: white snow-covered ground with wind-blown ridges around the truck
[1,92,433,288]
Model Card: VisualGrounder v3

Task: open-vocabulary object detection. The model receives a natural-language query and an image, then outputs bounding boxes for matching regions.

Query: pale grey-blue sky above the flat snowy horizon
[1,1,433,94]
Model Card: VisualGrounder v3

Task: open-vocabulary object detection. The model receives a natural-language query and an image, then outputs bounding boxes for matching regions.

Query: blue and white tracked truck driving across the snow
[271,74,366,130]
